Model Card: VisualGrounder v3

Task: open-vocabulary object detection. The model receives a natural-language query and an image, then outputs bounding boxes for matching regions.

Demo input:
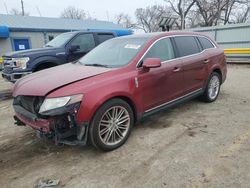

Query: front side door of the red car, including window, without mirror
[138,38,183,111]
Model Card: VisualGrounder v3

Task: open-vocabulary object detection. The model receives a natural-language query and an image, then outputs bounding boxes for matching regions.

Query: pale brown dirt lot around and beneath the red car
[0,65,250,188]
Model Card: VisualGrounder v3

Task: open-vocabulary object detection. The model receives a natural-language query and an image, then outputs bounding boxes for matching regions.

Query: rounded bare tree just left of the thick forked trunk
[135,5,170,33]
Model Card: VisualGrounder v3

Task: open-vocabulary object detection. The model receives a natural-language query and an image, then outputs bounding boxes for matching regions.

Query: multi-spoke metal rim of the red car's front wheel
[99,106,130,146]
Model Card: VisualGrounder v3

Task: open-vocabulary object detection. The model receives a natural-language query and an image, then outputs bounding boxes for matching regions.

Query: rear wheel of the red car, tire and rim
[202,72,221,102]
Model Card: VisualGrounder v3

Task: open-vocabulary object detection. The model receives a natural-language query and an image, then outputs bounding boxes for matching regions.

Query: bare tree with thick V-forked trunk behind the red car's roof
[164,0,195,29]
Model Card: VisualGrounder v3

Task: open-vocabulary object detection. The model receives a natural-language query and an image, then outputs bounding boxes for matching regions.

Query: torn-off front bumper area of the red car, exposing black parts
[13,105,89,145]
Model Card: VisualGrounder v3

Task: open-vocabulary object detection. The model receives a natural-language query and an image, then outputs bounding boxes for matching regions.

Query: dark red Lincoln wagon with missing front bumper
[13,32,227,151]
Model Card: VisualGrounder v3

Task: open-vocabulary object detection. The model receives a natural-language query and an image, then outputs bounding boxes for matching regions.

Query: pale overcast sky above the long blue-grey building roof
[0,0,165,21]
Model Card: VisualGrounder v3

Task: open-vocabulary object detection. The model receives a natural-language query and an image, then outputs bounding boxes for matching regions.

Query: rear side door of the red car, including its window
[174,36,209,95]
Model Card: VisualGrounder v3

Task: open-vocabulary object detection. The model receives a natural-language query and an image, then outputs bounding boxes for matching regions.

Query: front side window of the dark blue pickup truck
[71,34,95,52]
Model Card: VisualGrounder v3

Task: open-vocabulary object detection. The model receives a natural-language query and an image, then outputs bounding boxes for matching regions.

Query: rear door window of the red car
[174,36,200,57]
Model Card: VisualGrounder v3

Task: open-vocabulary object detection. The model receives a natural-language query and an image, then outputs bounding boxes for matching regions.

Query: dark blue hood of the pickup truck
[3,47,60,58]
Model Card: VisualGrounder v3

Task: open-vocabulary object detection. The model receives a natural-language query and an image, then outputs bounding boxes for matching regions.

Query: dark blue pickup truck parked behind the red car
[2,31,117,82]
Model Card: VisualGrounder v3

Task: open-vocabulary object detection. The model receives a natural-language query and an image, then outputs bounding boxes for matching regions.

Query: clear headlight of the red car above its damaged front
[39,94,83,113]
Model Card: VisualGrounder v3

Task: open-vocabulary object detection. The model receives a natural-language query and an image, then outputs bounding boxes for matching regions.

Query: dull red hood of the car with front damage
[13,63,111,97]
